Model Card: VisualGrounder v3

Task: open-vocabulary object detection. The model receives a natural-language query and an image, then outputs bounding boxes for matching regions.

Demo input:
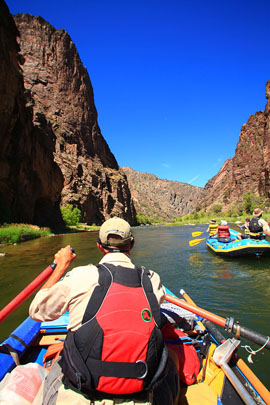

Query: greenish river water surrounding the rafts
[0,225,270,389]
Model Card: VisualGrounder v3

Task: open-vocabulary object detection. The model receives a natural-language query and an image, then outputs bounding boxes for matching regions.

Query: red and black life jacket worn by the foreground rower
[60,263,168,398]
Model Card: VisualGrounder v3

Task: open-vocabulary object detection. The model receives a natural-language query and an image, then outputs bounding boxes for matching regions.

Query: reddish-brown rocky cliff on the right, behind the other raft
[204,81,270,206]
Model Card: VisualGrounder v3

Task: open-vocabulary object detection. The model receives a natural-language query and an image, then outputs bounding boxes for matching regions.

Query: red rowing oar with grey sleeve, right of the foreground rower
[165,294,270,350]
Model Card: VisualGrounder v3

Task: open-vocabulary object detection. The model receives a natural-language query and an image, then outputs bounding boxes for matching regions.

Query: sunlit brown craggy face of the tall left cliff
[14,14,136,224]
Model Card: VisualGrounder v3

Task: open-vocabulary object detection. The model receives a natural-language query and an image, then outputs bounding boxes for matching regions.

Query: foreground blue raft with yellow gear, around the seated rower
[0,290,270,405]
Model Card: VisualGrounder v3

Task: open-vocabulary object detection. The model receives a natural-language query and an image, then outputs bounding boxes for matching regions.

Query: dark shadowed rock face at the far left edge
[0,1,63,228]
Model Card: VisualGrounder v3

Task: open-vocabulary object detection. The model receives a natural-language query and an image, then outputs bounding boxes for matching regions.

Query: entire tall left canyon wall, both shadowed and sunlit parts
[0,0,136,227]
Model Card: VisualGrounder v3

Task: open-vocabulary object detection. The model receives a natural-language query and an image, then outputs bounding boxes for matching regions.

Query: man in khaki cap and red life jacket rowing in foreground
[29,217,180,405]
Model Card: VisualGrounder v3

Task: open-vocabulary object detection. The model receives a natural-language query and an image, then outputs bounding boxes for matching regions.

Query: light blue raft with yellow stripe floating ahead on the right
[206,229,270,257]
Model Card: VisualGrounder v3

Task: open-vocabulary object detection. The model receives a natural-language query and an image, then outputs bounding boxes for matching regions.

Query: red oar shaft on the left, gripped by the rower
[0,248,75,323]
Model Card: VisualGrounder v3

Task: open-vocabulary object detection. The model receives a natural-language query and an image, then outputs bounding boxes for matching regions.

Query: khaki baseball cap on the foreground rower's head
[99,217,133,246]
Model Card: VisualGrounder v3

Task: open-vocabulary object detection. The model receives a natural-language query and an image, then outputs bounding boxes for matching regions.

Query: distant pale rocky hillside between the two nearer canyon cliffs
[122,167,203,221]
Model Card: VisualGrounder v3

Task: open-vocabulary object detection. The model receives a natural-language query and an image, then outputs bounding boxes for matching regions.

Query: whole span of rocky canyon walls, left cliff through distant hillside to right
[0,0,270,224]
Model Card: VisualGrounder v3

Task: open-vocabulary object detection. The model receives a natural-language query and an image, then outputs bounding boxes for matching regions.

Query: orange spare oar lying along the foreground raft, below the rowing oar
[180,289,270,404]
